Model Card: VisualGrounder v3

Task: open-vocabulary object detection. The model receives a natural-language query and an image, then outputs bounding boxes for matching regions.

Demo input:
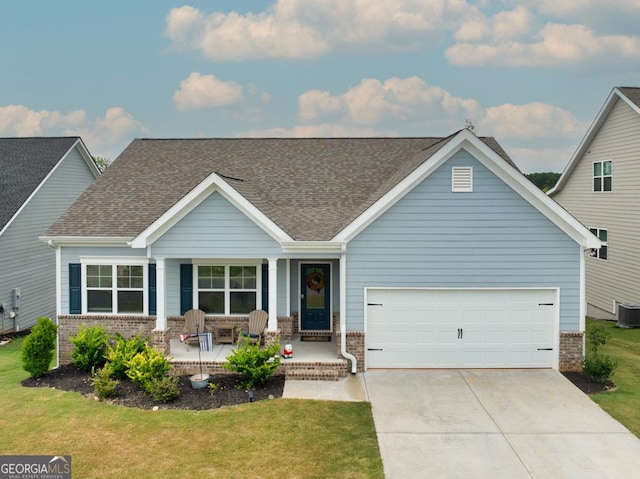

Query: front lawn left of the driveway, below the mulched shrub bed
[0,339,384,479]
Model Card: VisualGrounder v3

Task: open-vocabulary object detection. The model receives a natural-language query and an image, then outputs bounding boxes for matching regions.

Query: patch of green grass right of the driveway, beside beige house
[587,319,640,437]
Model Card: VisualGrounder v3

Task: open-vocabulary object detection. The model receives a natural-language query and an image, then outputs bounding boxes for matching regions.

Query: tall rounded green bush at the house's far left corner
[20,318,58,378]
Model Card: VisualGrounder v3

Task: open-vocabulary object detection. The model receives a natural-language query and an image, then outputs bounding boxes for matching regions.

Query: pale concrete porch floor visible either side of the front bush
[169,337,344,365]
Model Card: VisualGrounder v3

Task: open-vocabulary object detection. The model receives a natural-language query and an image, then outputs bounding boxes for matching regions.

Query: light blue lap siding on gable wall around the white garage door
[347,151,581,331]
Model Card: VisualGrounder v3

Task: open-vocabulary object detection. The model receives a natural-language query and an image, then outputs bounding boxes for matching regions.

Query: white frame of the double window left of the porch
[80,256,149,316]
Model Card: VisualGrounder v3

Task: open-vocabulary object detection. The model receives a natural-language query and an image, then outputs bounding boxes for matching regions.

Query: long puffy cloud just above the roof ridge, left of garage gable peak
[298,76,481,127]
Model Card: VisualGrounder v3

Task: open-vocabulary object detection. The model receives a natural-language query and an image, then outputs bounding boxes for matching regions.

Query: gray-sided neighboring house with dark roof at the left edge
[0,137,99,332]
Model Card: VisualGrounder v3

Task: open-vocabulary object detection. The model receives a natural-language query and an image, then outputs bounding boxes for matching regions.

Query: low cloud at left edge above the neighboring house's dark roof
[0,105,148,159]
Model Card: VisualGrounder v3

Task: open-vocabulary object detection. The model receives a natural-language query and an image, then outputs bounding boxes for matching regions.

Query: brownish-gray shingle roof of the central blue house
[47,134,515,241]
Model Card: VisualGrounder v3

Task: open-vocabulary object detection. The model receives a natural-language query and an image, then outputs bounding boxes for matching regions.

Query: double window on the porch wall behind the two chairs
[196,265,259,315]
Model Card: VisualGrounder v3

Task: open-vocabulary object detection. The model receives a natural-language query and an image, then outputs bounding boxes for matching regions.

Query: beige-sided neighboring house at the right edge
[549,87,640,319]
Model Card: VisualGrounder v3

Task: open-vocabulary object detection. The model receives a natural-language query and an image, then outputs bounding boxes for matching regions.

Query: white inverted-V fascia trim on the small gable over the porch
[131,173,293,248]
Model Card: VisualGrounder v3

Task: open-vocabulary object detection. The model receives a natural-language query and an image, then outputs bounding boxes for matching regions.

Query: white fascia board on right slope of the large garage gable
[464,138,602,248]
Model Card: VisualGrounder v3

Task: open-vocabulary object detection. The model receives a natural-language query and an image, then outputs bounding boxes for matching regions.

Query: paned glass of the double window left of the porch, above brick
[83,263,146,314]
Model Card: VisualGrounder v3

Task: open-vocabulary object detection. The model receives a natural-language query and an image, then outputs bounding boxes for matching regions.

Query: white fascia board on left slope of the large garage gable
[331,129,475,243]
